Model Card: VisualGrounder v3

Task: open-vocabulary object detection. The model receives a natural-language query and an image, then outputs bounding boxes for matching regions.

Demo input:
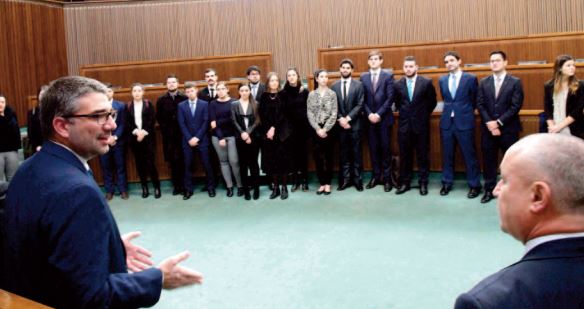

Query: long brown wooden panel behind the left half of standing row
[79,53,272,87]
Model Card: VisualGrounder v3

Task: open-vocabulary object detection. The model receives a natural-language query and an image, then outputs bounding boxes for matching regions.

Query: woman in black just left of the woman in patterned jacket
[282,67,312,192]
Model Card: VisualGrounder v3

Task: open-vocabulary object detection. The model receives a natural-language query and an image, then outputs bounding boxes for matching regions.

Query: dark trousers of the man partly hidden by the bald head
[481,126,519,191]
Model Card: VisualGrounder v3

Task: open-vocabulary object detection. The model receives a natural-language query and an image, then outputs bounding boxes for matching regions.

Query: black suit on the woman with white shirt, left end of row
[126,100,160,188]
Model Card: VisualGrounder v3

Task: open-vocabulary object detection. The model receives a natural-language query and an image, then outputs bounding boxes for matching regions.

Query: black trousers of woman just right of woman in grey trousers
[236,138,260,187]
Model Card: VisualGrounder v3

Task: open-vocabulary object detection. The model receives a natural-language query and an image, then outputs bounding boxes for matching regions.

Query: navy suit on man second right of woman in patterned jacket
[361,70,394,182]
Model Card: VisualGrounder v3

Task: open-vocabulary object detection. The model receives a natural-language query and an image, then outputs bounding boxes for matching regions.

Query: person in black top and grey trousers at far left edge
[0,94,20,182]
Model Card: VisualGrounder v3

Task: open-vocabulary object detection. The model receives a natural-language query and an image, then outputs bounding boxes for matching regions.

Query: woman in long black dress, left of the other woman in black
[259,72,292,200]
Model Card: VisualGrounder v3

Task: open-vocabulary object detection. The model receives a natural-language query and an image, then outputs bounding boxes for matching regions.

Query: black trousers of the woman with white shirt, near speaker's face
[130,136,160,188]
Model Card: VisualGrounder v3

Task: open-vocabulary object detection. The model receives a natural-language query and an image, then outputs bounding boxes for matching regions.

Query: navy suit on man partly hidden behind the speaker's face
[99,100,128,193]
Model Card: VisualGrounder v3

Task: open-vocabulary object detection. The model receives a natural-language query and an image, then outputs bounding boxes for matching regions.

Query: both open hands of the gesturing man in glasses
[122,232,203,290]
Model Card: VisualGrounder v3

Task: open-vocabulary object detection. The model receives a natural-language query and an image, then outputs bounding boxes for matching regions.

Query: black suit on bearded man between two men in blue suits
[395,75,436,186]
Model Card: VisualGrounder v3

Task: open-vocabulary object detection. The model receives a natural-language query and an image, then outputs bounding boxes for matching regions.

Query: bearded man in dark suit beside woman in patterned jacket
[331,59,365,191]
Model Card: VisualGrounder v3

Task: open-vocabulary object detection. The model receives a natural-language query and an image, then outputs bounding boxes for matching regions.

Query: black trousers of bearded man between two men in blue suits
[397,129,430,185]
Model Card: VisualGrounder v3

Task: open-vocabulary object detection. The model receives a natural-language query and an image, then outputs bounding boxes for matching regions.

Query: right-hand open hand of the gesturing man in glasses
[158,251,203,290]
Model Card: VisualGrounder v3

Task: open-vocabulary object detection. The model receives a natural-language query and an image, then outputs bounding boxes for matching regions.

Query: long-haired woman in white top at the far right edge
[544,55,584,138]
